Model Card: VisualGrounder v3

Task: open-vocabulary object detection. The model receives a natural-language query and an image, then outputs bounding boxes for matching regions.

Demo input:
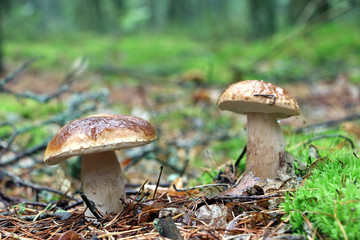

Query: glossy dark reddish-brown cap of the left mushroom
[44,114,156,165]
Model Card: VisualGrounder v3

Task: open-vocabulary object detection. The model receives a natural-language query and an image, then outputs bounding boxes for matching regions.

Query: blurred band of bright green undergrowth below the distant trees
[4,23,360,84]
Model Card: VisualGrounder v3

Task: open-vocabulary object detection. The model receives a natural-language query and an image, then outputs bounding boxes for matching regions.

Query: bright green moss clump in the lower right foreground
[282,151,360,239]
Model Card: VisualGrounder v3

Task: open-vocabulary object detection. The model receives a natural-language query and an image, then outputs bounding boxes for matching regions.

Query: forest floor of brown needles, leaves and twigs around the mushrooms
[0,62,360,239]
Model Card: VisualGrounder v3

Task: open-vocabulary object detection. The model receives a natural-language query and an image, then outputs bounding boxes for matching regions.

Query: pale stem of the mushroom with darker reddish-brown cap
[81,151,126,217]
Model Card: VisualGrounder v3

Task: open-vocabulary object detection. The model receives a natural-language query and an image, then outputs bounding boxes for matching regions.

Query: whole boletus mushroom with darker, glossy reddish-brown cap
[44,114,156,217]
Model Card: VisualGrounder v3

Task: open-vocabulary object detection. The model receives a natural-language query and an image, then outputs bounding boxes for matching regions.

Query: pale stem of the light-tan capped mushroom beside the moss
[246,113,285,179]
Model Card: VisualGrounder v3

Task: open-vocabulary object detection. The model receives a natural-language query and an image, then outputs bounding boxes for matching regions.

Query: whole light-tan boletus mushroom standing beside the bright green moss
[217,80,300,179]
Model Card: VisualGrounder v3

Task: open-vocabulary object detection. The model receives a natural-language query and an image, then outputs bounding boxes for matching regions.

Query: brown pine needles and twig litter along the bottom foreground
[0,179,296,240]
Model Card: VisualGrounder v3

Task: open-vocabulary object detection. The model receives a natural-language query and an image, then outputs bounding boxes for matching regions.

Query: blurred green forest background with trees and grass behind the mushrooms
[0,0,360,85]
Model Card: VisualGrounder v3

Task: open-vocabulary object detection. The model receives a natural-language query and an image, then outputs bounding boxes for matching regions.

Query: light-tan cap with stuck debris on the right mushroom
[217,80,300,118]
